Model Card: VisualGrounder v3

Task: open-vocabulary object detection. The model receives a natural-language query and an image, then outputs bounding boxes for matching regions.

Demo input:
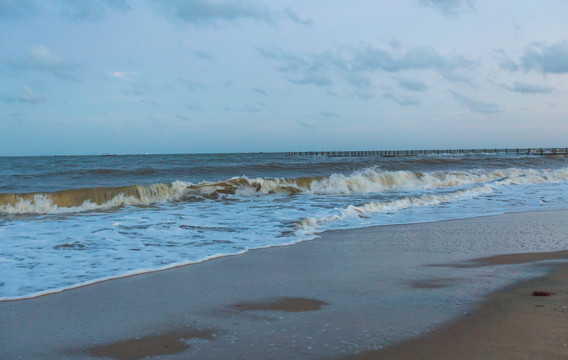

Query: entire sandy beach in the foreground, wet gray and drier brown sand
[0,211,568,359]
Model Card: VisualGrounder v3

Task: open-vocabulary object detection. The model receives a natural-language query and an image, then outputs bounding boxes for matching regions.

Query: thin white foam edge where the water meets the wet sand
[0,209,568,303]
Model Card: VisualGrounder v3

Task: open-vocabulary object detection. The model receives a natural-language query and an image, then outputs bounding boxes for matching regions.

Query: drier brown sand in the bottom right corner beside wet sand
[339,253,568,360]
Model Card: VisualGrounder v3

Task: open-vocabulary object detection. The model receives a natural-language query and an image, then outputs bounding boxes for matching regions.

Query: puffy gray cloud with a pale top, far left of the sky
[10,45,79,81]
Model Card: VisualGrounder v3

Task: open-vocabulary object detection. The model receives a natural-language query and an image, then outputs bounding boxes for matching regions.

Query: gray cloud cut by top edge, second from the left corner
[59,0,130,21]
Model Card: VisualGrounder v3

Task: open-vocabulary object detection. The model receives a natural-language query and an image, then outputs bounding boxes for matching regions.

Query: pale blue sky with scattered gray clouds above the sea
[0,0,568,156]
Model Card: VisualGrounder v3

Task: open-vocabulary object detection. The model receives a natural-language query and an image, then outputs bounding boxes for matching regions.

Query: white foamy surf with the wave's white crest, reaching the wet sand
[0,168,568,299]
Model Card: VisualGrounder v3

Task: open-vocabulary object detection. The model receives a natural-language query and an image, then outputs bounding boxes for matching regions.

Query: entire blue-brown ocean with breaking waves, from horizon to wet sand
[0,153,568,300]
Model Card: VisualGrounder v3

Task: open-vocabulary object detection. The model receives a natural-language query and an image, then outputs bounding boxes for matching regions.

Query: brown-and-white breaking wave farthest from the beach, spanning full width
[0,168,568,214]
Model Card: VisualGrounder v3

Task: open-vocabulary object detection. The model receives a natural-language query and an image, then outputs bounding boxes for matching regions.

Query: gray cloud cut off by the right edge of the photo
[520,40,568,74]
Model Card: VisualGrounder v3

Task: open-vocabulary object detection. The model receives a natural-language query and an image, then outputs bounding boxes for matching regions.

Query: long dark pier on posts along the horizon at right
[286,148,568,157]
